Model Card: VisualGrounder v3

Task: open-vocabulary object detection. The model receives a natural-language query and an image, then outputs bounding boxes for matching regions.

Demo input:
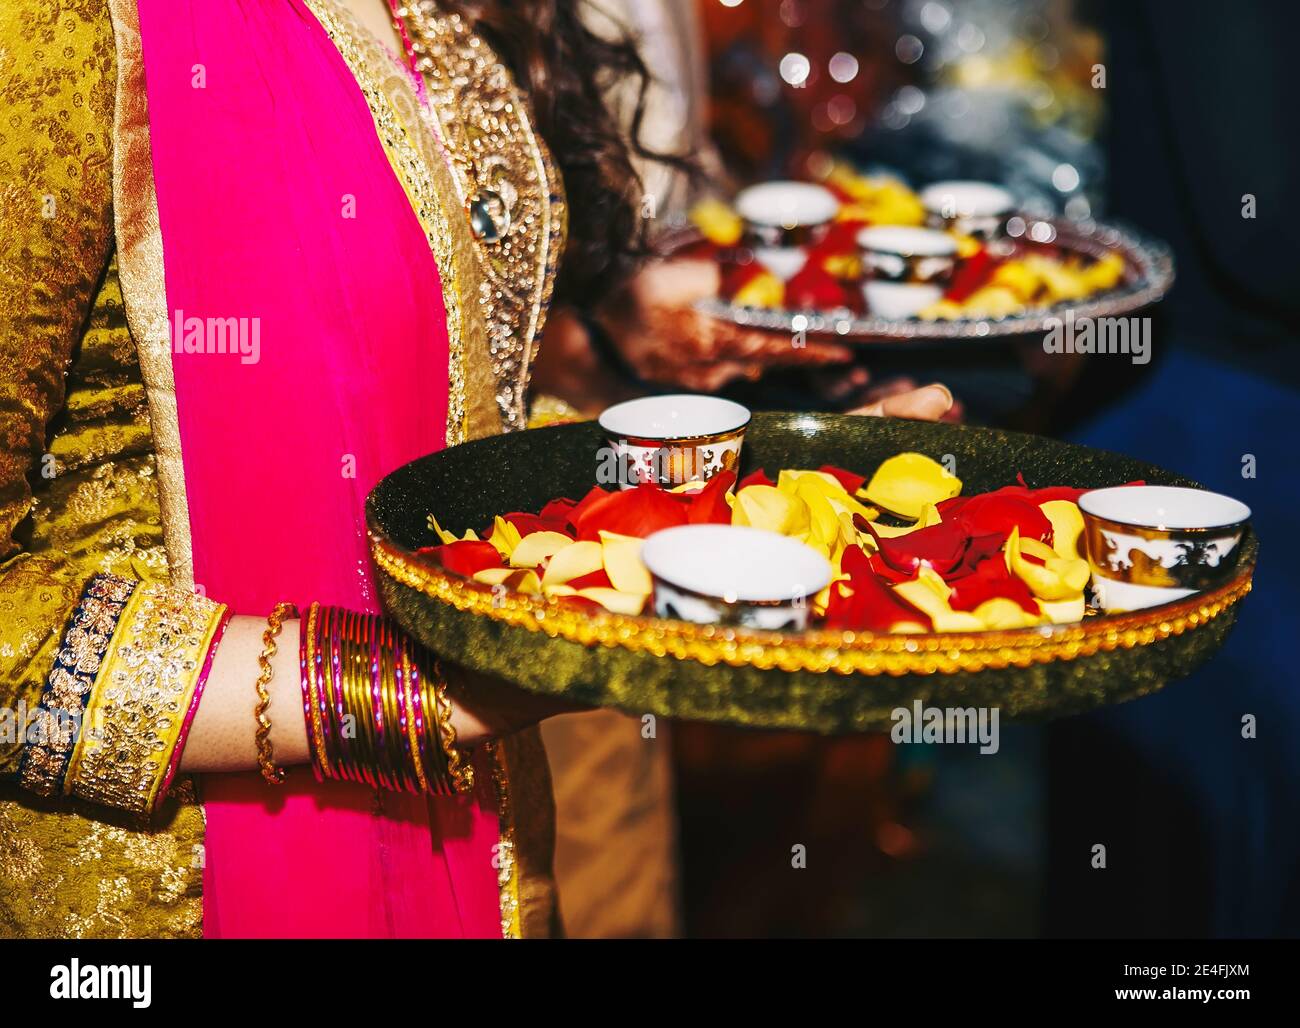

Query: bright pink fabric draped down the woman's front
[139,0,501,937]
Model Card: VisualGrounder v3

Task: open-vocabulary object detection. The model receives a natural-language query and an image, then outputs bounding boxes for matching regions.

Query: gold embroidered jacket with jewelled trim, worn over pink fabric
[0,0,564,937]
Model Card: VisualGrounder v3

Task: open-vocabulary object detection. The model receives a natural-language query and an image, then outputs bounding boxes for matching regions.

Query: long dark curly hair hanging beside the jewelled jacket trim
[449,0,694,305]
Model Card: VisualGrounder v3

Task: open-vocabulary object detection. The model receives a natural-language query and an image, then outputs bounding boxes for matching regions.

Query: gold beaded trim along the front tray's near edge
[371,535,1255,676]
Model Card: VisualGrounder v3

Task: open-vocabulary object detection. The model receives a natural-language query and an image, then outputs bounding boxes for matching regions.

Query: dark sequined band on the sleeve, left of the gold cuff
[18,574,135,795]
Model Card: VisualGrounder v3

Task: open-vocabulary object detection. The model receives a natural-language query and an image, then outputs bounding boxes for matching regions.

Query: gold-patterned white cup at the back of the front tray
[597,394,750,489]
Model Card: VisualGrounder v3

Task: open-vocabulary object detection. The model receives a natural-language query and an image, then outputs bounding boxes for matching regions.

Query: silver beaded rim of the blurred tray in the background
[691,216,1174,344]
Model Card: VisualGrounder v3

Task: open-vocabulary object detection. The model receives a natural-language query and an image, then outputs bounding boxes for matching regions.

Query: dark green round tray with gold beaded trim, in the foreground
[367,413,1257,733]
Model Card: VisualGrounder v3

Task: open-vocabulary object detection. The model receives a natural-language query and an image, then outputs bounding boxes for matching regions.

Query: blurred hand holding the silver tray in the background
[595,257,853,392]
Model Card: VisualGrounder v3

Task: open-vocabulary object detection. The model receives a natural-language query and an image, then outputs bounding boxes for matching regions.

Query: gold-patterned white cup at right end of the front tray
[1079,486,1251,612]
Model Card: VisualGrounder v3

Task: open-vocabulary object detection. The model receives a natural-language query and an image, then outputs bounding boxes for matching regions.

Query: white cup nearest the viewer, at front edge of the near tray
[641,525,833,630]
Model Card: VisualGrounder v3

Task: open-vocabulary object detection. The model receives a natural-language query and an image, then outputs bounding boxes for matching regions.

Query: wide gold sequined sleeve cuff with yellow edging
[64,582,226,817]
